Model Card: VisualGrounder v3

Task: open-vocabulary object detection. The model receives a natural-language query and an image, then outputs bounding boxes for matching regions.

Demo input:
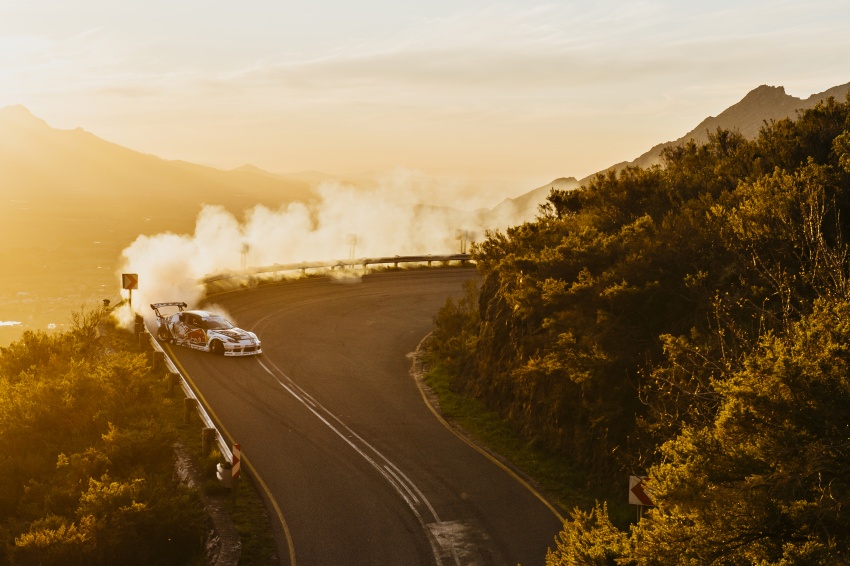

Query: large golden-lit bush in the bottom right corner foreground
[632,300,850,564]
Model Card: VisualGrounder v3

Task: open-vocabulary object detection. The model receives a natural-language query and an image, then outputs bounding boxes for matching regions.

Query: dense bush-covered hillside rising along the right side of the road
[426,95,850,566]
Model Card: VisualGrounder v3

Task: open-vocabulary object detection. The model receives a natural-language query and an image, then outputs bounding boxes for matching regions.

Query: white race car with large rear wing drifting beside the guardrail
[151,302,263,356]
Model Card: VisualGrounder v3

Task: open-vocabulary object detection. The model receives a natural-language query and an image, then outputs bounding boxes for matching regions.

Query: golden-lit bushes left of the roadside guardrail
[0,311,205,565]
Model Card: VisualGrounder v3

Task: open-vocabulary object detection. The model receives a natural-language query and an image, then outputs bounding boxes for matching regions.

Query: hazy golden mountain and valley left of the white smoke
[0,106,315,345]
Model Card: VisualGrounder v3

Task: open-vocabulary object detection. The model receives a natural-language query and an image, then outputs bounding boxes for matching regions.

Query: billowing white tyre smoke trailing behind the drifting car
[117,171,528,324]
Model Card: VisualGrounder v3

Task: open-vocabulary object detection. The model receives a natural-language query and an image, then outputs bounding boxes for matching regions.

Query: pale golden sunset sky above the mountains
[0,0,850,192]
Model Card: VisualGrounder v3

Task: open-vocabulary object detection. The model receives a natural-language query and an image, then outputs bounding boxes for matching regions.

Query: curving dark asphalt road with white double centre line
[166,269,561,566]
